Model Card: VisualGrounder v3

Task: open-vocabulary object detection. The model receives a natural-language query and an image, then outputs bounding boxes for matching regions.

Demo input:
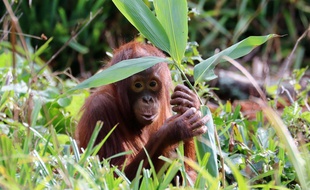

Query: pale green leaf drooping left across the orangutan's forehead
[71,56,169,90]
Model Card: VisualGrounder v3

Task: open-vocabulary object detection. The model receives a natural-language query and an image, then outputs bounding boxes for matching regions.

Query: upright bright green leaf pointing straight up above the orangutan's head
[154,0,188,63]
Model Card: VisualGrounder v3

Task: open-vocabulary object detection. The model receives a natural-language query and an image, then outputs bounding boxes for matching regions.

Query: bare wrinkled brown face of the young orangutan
[129,68,162,126]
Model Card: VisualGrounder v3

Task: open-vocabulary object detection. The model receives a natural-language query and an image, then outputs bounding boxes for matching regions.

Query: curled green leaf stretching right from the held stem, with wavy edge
[194,34,278,84]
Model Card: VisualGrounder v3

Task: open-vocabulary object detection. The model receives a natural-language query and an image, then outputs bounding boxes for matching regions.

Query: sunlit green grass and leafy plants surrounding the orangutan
[0,0,310,189]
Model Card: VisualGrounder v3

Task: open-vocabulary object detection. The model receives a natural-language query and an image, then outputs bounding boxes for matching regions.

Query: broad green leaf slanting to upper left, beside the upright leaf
[113,0,170,53]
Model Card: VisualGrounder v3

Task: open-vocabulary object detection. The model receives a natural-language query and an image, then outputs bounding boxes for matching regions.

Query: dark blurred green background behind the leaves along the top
[0,0,310,77]
